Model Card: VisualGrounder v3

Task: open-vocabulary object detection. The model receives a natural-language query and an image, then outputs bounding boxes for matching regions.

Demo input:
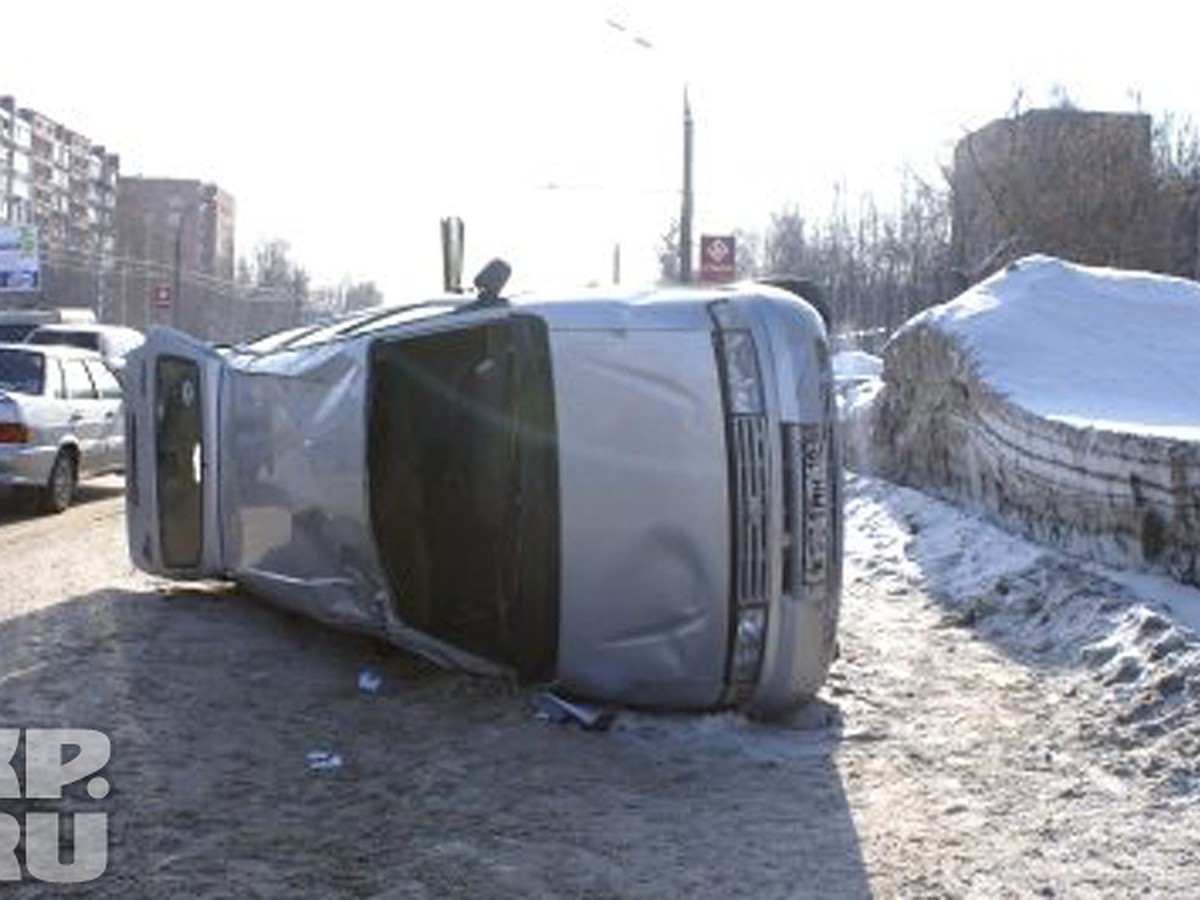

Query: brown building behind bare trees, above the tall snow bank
[953,108,1196,282]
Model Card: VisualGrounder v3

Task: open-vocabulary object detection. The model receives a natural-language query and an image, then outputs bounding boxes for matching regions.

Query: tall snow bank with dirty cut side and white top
[871,257,1200,583]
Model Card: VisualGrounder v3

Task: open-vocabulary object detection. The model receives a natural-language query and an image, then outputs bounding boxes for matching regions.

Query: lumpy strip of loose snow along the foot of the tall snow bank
[846,476,1200,793]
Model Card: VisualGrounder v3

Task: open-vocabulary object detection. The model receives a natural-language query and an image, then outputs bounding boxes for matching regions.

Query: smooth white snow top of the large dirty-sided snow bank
[905,256,1200,440]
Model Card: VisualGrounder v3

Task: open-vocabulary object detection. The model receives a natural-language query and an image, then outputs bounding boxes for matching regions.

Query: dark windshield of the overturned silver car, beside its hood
[367,317,558,678]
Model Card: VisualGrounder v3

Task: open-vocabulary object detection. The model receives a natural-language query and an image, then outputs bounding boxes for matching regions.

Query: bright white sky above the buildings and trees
[0,0,1200,301]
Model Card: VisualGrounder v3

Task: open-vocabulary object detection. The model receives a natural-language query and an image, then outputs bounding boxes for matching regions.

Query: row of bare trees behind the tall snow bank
[659,107,1200,348]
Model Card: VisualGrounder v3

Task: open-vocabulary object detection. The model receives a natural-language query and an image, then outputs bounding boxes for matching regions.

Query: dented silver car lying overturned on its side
[119,271,842,714]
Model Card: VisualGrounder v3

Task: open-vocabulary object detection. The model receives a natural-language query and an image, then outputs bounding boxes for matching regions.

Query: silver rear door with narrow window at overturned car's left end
[125,329,224,578]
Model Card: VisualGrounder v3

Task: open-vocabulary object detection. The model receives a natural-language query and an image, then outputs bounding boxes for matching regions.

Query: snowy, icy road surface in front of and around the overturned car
[0,479,1200,900]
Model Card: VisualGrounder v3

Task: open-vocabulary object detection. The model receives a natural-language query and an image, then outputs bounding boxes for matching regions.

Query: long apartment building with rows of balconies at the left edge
[0,96,120,311]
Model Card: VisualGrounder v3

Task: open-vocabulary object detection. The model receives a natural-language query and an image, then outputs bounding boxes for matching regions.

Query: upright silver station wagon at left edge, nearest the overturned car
[0,344,125,512]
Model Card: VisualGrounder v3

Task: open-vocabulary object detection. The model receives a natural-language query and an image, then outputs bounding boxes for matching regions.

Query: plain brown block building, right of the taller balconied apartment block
[116,178,236,334]
